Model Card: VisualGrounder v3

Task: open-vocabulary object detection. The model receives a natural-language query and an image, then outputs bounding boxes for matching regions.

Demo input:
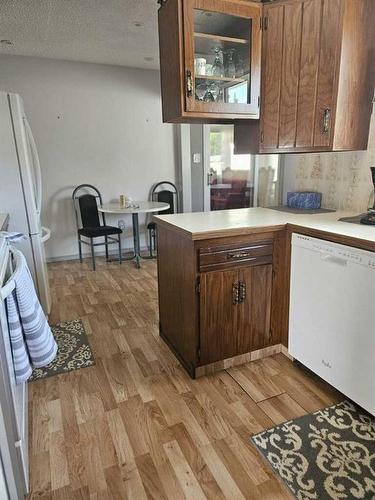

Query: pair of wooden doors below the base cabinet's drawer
[200,264,272,364]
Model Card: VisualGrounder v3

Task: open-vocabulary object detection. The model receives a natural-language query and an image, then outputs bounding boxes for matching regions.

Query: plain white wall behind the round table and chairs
[0,55,176,258]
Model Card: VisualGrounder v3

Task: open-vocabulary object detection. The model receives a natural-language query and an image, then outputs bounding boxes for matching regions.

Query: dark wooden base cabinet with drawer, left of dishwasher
[158,223,288,377]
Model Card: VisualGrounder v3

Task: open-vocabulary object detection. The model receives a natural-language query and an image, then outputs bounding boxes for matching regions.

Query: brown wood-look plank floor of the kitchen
[29,259,341,500]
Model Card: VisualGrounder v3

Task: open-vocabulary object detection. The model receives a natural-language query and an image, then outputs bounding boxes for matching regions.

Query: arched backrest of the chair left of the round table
[72,184,106,229]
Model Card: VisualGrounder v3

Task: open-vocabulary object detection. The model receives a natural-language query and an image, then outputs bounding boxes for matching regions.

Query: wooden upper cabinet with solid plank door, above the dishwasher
[235,0,375,153]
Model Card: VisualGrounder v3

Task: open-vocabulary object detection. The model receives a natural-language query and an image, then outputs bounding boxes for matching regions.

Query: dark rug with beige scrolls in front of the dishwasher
[251,401,375,500]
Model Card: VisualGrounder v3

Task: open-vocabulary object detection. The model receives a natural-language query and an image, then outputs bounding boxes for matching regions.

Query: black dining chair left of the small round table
[72,184,122,271]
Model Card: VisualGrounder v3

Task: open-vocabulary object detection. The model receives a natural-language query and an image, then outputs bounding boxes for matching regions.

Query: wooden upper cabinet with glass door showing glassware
[159,0,262,123]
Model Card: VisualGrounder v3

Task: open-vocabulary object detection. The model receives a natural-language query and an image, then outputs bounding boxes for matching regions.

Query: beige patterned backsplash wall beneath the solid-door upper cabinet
[284,113,375,213]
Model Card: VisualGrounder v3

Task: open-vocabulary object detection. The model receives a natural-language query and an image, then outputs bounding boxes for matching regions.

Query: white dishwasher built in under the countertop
[288,234,375,415]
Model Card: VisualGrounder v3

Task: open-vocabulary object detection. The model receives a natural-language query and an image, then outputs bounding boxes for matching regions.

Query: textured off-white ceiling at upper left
[0,0,159,69]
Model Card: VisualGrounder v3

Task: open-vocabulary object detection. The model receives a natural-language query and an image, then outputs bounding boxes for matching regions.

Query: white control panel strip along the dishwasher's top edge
[292,233,375,269]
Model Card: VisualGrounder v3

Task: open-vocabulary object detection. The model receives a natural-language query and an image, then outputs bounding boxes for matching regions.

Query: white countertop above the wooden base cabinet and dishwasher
[155,208,375,243]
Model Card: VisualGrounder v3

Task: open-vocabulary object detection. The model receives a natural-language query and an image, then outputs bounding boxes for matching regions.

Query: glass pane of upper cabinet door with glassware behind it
[193,9,251,104]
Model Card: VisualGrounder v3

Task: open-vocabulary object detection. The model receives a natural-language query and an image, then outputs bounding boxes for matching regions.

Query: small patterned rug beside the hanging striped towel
[28,319,95,382]
